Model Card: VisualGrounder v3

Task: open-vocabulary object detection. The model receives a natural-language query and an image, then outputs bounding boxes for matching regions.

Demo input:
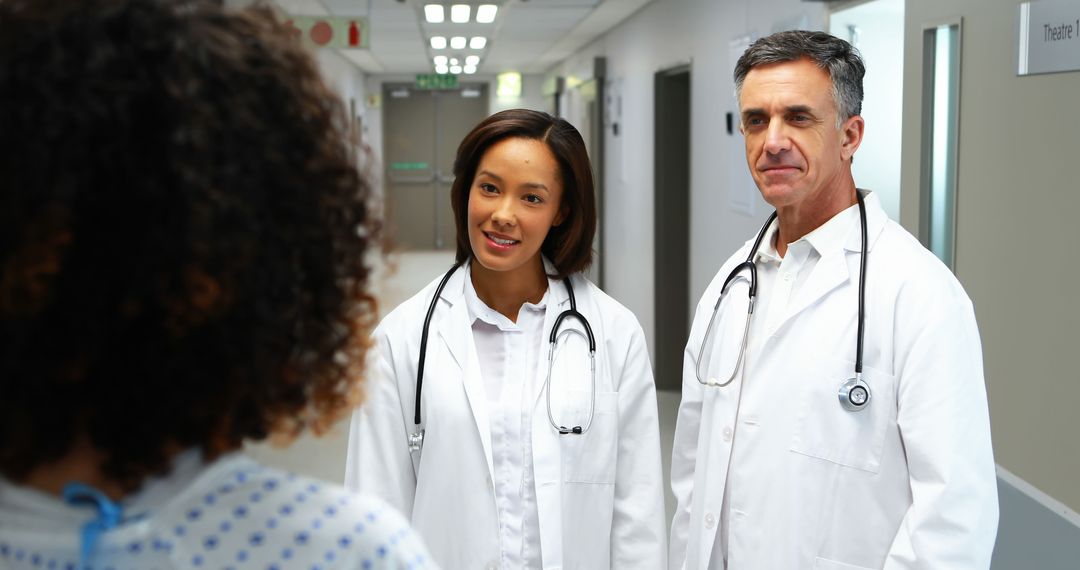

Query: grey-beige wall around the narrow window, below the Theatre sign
[901,0,1080,511]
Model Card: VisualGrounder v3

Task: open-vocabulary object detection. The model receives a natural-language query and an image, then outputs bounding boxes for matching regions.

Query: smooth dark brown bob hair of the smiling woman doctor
[450,109,596,277]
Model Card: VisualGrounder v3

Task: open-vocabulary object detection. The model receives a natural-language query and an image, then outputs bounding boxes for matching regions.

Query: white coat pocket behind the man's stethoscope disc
[791,358,896,473]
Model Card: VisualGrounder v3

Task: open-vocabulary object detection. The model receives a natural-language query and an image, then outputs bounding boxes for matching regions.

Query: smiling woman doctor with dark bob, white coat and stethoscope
[346,109,666,570]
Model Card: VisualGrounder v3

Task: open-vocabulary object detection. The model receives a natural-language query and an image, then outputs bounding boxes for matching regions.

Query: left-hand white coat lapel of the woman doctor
[432,271,495,476]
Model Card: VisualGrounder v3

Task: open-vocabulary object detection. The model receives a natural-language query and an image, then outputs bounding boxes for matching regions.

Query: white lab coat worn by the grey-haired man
[670,194,998,570]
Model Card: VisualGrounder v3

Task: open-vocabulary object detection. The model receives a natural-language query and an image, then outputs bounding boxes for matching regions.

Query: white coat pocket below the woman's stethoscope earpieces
[556,392,619,485]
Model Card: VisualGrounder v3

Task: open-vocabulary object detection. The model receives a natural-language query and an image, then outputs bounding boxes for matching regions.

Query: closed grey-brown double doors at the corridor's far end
[382,84,488,250]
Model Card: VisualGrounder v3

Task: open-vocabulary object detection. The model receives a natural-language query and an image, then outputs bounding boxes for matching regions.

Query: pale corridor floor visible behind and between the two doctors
[247,252,679,520]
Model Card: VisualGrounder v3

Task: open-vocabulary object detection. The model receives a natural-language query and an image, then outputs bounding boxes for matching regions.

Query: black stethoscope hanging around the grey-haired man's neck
[694,190,870,411]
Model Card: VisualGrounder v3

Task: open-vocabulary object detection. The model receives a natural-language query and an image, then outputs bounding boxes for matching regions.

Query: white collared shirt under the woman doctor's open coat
[464,263,551,569]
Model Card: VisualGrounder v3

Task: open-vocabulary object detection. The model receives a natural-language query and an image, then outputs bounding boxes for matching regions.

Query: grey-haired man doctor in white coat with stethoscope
[671,31,998,570]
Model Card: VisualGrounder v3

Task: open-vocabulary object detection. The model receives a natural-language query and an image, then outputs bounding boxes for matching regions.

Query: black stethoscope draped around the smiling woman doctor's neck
[408,263,596,452]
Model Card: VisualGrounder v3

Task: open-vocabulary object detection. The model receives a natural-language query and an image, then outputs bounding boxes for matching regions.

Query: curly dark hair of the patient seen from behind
[0,0,375,490]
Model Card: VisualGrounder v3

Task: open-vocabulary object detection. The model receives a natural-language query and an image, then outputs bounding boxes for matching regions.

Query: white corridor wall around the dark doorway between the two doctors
[549,0,824,358]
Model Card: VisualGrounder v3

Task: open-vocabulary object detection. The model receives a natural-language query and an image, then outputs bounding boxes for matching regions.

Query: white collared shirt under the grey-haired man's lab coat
[712,197,859,567]
